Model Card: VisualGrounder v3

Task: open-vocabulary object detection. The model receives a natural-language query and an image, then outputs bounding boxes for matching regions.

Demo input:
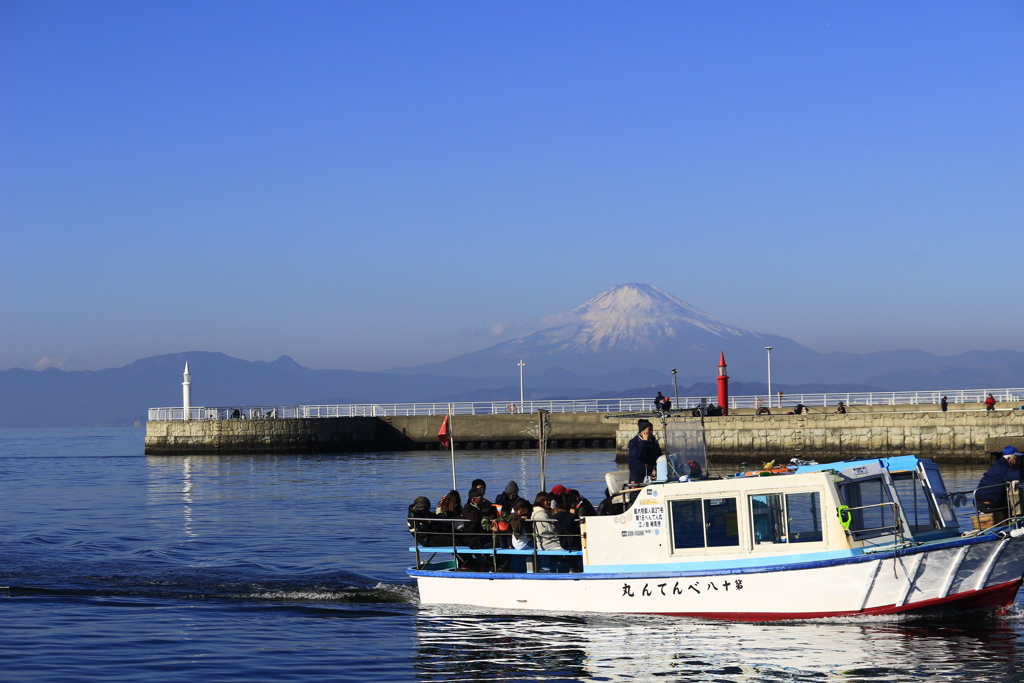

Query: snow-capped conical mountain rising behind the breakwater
[399,283,818,386]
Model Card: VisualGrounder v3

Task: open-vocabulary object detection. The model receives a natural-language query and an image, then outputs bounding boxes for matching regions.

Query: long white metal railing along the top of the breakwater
[148,388,1024,422]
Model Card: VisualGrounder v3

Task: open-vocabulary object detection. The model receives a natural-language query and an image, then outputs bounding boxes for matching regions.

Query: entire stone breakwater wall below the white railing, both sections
[145,407,1024,462]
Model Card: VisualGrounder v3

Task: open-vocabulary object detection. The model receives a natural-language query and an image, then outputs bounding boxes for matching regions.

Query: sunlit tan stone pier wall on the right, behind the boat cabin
[615,409,1024,463]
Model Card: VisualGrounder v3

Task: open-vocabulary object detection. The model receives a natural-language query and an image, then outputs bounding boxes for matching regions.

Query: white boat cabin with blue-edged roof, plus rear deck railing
[411,456,961,574]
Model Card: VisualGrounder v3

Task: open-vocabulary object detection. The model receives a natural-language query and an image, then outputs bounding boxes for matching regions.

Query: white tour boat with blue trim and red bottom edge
[409,448,1024,622]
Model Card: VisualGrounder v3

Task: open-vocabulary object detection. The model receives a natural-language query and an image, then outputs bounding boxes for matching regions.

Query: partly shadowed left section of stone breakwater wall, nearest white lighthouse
[145,413,618,456]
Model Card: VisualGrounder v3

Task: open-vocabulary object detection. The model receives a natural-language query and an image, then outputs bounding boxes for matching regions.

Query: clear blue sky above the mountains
[0,0,1024,370]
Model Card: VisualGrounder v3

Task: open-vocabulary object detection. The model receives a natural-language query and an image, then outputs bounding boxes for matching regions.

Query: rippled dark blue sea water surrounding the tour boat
[0,429,1024,682]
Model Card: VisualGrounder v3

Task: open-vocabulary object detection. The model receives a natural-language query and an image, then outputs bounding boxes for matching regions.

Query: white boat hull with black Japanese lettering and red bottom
[409,536,1024,622]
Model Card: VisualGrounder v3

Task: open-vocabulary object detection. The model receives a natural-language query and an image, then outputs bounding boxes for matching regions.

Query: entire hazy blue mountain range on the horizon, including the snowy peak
[0,284,1024,427]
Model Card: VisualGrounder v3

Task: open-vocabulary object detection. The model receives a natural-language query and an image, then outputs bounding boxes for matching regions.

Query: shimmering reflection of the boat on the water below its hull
[413,607,1024,682]
